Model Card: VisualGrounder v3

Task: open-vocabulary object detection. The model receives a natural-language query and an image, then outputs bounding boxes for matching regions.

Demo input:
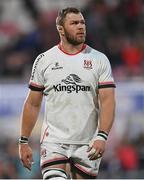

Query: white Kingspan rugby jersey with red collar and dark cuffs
[29,44,115,144]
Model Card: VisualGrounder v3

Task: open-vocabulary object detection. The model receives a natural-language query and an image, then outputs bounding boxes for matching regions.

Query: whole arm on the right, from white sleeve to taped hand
[88,54,115,159]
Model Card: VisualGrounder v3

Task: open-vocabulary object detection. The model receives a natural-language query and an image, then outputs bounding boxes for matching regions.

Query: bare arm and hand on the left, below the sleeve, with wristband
[19,90,43,170]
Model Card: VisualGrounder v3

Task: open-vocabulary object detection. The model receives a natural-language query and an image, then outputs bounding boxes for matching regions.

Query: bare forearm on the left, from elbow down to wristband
[21,102,40,137]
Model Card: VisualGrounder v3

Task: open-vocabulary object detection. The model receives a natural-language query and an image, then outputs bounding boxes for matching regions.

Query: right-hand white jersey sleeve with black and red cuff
[98,54,116,89]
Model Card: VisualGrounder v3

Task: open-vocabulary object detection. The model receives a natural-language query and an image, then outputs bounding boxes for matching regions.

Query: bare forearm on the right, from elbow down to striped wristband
[99,96,115,133]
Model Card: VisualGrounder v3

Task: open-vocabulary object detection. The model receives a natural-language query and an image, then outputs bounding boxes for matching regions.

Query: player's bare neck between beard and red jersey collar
[59,41,84,54]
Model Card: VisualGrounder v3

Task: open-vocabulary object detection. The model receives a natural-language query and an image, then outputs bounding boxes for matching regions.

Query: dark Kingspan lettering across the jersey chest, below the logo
[53,84,91,93]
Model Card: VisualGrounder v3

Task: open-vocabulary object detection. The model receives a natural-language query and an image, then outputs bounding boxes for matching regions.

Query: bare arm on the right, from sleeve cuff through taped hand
[88,88,115,160]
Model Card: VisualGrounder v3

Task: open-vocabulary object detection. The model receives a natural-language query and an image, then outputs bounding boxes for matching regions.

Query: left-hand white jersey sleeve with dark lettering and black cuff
[29,54,44,91]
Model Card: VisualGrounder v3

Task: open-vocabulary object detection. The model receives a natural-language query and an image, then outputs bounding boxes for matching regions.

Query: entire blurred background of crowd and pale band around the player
[0,0,144,179]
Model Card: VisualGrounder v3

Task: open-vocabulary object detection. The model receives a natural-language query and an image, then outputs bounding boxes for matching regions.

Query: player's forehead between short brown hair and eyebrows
[65,13,84,22]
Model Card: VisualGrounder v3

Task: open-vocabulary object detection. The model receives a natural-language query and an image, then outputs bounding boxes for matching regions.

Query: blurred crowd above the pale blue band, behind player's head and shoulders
[0,0,144,80]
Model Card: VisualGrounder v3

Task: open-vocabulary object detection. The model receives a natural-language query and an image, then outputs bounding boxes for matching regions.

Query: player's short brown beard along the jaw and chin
[64,28,85,45]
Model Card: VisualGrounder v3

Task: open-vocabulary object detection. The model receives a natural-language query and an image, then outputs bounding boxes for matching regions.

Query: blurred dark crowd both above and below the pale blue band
[0,0,144,179]
